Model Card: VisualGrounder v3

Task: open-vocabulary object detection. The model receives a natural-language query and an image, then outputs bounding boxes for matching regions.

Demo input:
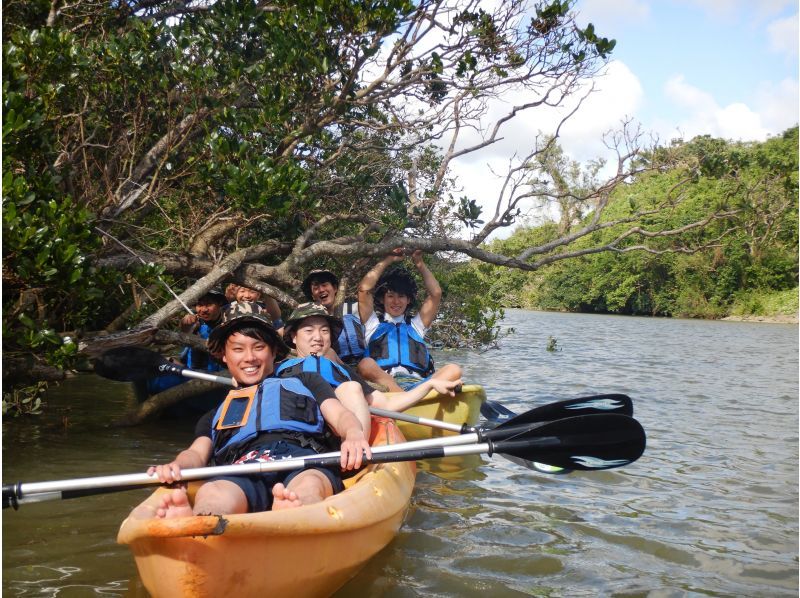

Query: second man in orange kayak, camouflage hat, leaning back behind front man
[275,303,462,430]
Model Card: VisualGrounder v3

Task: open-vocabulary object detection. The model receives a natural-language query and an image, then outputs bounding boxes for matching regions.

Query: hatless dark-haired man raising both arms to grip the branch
[358,248,461,389]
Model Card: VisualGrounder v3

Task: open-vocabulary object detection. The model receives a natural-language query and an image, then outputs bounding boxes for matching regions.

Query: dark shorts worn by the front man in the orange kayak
[208,440,344,513]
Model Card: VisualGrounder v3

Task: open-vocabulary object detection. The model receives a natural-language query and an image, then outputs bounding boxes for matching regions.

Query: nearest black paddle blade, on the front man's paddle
[492,414,646,471]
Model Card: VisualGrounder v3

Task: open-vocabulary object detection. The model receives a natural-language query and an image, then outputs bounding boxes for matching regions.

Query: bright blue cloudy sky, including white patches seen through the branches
[451,0,800,238]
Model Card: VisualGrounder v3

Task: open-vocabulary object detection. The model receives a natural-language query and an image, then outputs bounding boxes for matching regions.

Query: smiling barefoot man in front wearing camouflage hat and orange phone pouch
[144,302,372,518]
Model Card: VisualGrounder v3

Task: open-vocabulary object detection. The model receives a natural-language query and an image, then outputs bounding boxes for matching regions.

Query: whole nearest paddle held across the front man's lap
[3,414,646,508]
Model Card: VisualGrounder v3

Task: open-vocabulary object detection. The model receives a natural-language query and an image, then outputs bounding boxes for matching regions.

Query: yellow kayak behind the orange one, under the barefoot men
[396,384,486,440]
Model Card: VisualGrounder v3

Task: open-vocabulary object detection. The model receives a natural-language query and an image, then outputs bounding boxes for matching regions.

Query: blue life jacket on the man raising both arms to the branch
[365,322,434,376]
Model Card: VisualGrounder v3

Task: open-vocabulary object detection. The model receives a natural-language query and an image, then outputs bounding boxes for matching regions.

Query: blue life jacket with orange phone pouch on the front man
[211,378,325,463]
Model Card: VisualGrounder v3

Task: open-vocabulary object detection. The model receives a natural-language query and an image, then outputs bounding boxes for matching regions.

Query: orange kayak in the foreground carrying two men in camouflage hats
[117,418,416,598]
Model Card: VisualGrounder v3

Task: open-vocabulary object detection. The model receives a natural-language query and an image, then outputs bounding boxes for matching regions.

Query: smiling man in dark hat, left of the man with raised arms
[301,270,403,392]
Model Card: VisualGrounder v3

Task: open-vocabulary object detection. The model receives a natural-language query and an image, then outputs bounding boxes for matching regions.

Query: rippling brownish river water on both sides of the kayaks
[2,310,798,598]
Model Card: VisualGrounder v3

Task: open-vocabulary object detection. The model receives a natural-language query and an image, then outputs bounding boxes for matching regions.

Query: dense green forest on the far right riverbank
[456,127,798,318]
